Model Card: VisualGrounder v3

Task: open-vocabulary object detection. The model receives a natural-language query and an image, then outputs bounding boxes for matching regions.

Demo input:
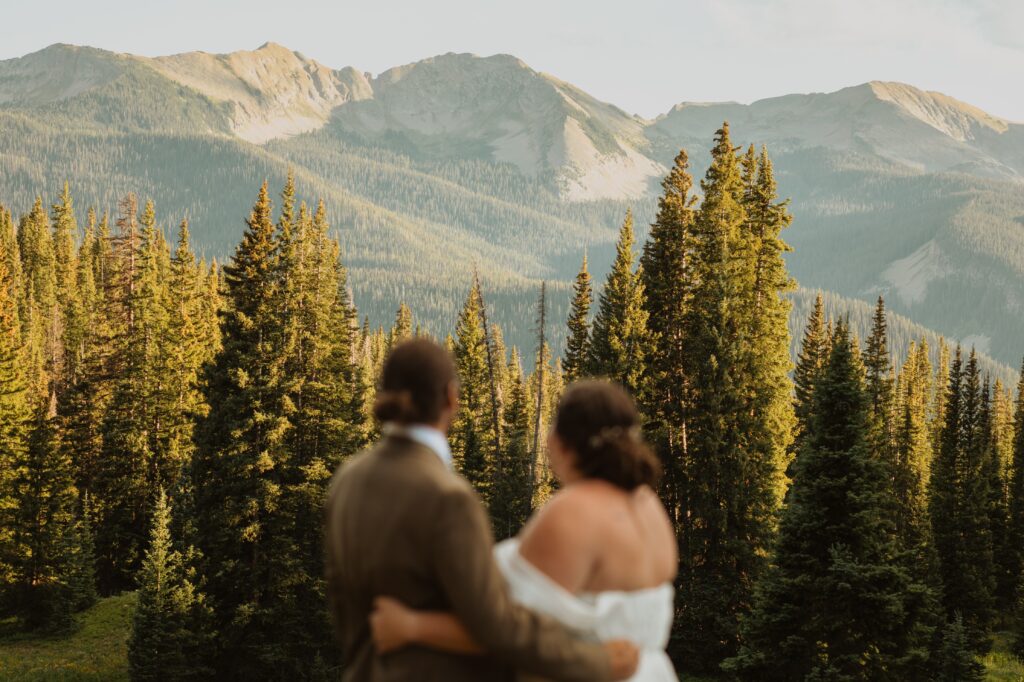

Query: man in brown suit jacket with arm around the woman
[327,339,638,682]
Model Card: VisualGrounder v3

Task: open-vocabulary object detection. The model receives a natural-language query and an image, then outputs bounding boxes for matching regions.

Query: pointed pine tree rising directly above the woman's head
[589,211,650,395]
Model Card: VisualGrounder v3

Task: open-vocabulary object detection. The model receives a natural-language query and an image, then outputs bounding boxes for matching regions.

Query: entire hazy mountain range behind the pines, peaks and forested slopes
[0,43,1024,365]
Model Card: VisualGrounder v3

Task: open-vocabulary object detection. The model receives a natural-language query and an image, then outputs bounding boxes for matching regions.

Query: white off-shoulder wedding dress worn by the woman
[495,538,679,682]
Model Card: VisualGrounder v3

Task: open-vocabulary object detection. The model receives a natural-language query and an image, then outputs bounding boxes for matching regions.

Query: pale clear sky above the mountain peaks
[6,0,1024,122]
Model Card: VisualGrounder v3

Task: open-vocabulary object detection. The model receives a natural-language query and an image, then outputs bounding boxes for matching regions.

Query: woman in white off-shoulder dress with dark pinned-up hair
[371,381,678,682]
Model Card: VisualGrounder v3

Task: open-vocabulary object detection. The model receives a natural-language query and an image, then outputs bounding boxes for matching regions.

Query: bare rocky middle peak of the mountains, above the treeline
[325,54,665,201]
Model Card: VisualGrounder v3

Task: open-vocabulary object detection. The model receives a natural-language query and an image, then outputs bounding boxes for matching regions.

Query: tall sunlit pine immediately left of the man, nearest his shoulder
[274,196,364,677]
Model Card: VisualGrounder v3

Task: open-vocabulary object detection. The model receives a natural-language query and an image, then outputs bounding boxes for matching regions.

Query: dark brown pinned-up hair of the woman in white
[555,381,662,491]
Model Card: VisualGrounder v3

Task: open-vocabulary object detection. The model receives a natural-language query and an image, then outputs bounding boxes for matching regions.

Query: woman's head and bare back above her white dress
[521,381,677,594]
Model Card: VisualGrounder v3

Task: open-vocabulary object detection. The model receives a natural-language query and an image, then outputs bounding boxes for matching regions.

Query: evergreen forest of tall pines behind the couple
[0,124,1024,682]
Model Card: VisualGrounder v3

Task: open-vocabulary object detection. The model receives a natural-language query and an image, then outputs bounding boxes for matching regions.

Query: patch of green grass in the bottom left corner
[0,593,135,682]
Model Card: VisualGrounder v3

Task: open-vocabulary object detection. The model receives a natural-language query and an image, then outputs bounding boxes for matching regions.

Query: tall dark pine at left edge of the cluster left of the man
[191,182,288,677]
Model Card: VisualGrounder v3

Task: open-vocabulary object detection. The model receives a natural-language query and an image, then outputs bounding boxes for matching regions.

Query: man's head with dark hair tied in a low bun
[374,339,456,424]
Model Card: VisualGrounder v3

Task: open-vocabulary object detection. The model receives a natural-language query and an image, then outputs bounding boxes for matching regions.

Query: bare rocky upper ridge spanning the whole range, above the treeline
[6,43,1024,201]
